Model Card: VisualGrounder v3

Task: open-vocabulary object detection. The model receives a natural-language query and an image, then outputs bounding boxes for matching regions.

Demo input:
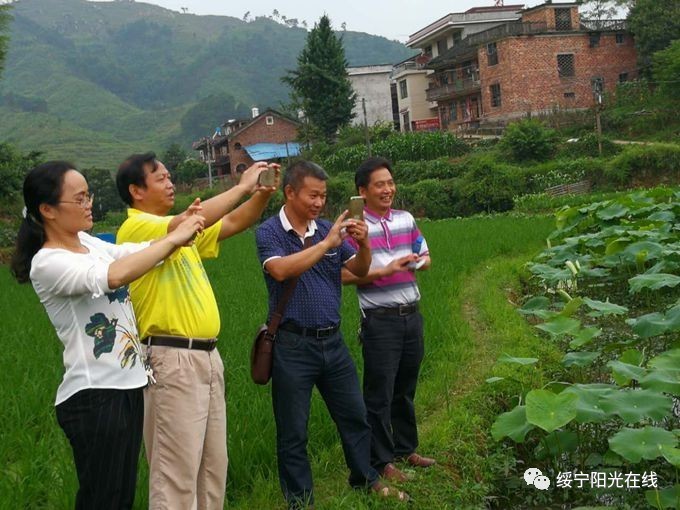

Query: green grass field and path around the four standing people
[0,216,552,510]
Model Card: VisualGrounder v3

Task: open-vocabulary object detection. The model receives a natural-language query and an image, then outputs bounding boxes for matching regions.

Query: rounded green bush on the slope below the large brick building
[500,119,557,161]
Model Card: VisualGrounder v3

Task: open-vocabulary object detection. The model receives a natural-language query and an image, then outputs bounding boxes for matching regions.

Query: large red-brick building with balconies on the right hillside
[427,3,637,129]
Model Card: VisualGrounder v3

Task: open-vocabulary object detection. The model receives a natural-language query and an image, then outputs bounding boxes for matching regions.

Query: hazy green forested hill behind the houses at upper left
[0,0,413,166]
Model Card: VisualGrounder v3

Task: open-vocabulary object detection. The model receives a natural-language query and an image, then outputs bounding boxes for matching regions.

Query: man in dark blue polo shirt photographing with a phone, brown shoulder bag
[256,161,407,508]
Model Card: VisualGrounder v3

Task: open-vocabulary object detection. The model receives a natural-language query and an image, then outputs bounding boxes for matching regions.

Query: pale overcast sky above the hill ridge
[121,0,543,42]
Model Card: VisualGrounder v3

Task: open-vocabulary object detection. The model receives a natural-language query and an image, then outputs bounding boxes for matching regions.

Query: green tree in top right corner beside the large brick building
[628,0,680,66]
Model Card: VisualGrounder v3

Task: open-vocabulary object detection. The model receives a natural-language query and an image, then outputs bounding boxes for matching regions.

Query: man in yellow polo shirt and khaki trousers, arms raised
[116,153,278,510]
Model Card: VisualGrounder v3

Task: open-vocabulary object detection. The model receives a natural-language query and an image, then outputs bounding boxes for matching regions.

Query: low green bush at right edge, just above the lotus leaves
[604,143,680,186]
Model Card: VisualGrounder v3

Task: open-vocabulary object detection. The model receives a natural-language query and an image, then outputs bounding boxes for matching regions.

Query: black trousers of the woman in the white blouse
[56,388,144,510]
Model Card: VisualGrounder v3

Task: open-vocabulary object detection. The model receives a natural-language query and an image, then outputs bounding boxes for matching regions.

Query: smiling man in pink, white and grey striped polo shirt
[342,157,435,482]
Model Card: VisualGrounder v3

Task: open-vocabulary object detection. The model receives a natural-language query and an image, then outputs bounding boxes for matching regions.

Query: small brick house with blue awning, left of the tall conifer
[192,108,300,177]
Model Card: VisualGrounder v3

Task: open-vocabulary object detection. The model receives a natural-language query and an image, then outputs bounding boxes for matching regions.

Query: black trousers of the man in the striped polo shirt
[361,311,424,470]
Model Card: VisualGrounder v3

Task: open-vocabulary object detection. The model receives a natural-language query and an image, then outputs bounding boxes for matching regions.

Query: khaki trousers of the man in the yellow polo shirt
[144,345,227,510]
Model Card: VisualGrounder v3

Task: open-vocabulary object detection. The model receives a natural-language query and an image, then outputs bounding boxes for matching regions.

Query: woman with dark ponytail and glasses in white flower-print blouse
[12,161,203,510]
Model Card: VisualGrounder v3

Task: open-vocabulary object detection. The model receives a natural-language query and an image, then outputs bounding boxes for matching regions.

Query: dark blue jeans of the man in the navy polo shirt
[272,330,378,507]
